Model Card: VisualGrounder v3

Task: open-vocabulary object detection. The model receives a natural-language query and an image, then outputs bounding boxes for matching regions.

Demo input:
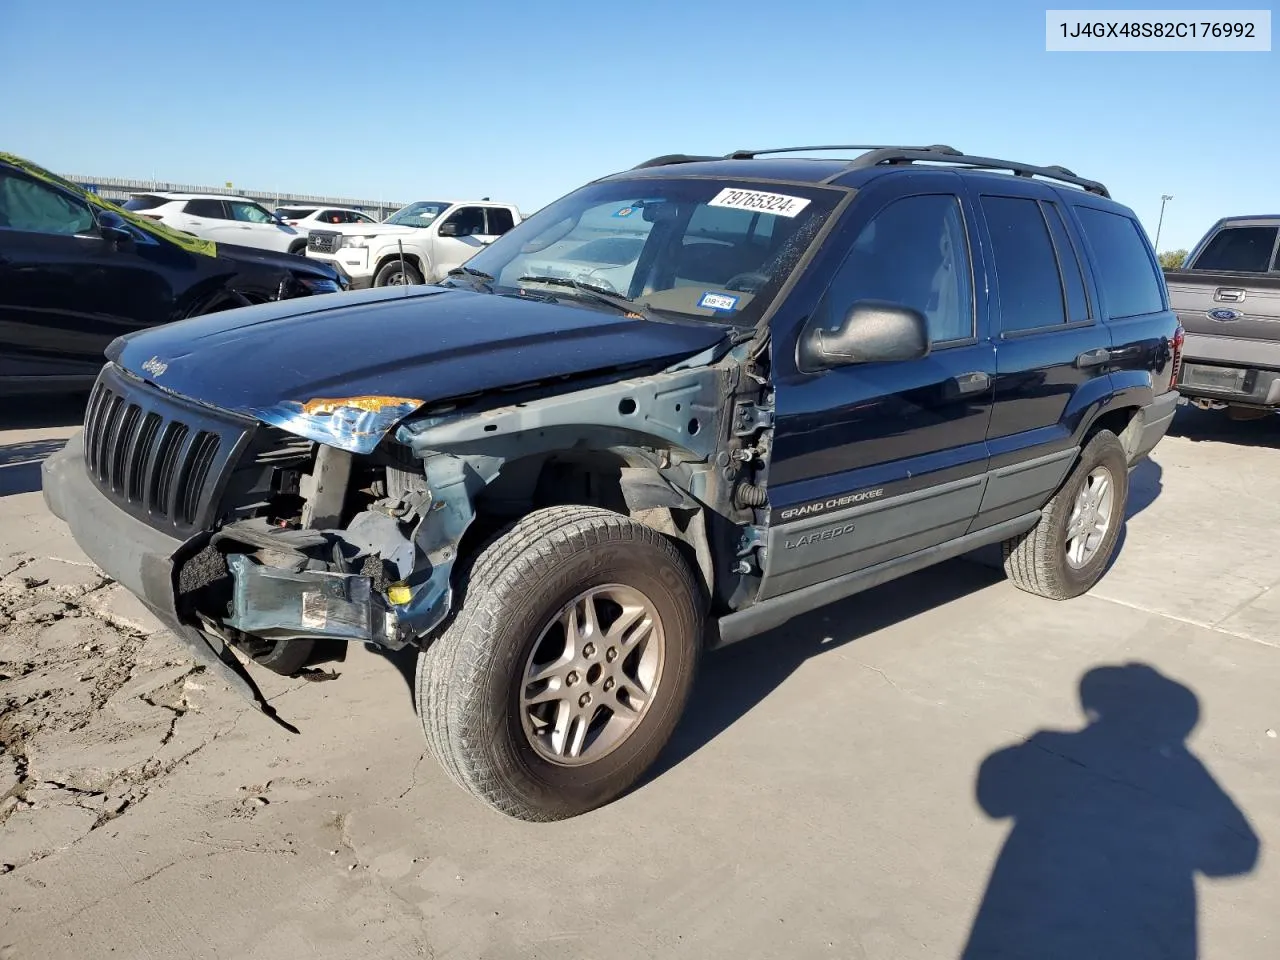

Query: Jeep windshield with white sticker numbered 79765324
[456,179,841,324]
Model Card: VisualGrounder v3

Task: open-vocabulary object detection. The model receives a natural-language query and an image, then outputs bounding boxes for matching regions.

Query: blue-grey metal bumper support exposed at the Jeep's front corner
[225,553,387,643]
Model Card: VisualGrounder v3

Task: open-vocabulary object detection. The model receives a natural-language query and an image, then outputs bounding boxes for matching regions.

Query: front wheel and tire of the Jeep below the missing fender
[417,507,703,820]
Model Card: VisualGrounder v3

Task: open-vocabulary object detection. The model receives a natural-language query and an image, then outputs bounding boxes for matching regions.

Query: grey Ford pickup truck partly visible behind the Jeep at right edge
[1165,215,1280,417]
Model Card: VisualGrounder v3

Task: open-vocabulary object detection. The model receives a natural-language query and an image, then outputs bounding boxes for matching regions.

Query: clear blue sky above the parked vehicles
[0,0,1280,250]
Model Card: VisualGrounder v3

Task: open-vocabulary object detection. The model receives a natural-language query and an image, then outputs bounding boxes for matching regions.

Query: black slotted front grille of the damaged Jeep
[84,366,246,535]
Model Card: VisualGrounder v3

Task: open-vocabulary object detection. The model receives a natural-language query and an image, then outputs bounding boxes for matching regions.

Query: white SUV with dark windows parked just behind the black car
[124,193,307,256]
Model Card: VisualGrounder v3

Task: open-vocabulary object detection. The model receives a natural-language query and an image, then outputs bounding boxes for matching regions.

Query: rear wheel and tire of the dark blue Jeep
[1004,430,1129,600]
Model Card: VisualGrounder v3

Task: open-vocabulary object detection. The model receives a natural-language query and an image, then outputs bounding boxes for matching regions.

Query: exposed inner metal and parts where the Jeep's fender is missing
[177,352,772,672]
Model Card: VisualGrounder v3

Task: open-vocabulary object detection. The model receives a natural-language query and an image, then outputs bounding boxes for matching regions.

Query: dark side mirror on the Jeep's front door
[799,300,929,371]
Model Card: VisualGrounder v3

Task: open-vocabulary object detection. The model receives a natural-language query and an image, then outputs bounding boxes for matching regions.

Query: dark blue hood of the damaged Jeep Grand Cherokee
[106,287,732,453]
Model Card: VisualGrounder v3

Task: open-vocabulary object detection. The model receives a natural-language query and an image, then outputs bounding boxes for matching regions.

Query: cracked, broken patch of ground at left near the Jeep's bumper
[0,557,216,872]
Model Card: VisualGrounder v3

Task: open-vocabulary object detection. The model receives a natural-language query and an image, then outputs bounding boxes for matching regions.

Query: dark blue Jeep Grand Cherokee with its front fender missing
[44,147,1180,819]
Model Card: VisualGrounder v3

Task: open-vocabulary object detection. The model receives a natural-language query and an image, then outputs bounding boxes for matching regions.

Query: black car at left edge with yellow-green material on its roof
[0,154,343,394]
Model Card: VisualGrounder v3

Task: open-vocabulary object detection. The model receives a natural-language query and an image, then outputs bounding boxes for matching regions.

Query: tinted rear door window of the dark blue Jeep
[982,197,1066,333]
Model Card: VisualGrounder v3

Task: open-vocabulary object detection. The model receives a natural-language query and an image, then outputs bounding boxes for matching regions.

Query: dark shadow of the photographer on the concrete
[963,663,1260,960]
